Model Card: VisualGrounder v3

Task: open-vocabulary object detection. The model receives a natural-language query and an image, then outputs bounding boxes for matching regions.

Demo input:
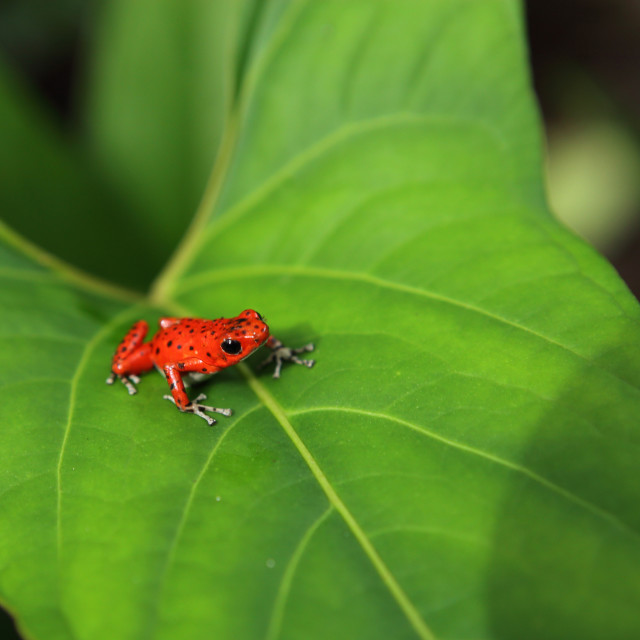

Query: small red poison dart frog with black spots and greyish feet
[107,309,315,425]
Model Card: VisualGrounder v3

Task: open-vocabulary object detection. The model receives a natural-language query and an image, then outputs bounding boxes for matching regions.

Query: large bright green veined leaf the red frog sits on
[0,0,640,640]
